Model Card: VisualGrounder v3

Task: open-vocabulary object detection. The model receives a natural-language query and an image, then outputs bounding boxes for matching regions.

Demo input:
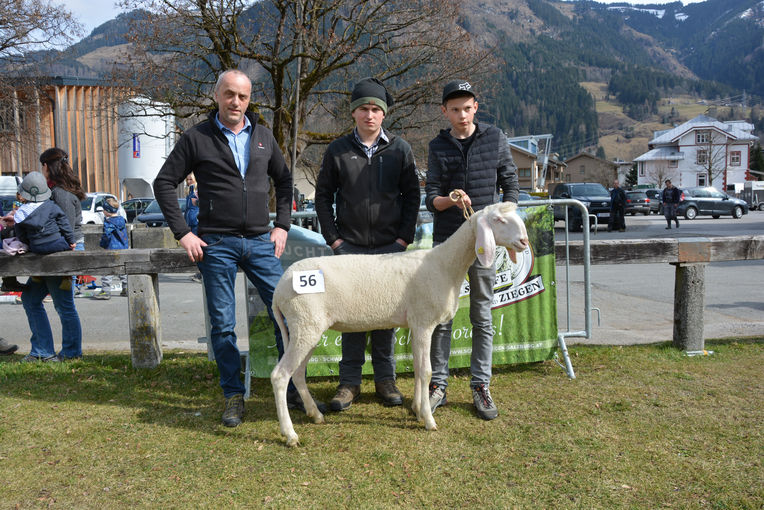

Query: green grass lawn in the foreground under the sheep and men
[0,339,764,509]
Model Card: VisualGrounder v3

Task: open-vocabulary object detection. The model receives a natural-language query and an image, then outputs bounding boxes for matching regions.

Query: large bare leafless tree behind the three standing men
[114,0,493,170]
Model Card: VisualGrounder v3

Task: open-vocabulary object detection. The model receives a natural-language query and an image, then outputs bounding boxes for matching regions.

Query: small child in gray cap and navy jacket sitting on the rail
[13,172,75,254]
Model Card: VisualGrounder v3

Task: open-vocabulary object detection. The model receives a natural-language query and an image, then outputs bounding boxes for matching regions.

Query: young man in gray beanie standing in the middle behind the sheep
[316,78,419,411]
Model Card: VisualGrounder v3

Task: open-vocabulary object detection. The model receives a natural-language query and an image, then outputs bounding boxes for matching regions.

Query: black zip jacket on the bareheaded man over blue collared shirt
[154,110,292,239]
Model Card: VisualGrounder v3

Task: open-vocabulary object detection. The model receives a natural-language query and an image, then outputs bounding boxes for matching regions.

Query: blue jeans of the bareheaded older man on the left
[198,232,293,398]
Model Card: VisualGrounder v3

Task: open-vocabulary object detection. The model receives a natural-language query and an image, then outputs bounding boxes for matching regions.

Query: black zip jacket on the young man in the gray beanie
[316,131,419,248]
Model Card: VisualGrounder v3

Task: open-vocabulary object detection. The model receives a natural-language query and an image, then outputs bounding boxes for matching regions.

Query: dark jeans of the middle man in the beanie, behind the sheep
[334,241,406,386]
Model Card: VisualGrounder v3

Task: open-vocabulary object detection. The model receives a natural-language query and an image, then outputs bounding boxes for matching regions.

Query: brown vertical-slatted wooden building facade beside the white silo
[0,77,126,196]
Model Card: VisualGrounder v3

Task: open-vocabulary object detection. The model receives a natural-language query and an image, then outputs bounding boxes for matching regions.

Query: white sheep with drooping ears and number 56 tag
[271,202,528,446]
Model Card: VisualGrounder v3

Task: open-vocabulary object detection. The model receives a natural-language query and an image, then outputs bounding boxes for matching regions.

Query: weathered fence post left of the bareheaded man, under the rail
[127,274,162,368]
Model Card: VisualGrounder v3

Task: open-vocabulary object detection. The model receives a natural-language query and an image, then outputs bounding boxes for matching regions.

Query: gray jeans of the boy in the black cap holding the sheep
[430,260,496,388]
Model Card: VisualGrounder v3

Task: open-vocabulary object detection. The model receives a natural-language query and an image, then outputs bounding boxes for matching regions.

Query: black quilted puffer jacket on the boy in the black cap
[425,122,519,243]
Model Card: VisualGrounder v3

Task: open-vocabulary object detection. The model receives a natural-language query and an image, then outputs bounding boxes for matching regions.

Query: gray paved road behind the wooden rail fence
[0,211,764,352]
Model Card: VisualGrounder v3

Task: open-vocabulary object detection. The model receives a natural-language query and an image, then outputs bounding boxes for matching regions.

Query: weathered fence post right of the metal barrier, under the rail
[674,263,706,351]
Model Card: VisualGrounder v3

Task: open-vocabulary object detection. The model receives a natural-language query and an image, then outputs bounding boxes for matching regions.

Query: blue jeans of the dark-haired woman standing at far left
[21,276,82,358]
